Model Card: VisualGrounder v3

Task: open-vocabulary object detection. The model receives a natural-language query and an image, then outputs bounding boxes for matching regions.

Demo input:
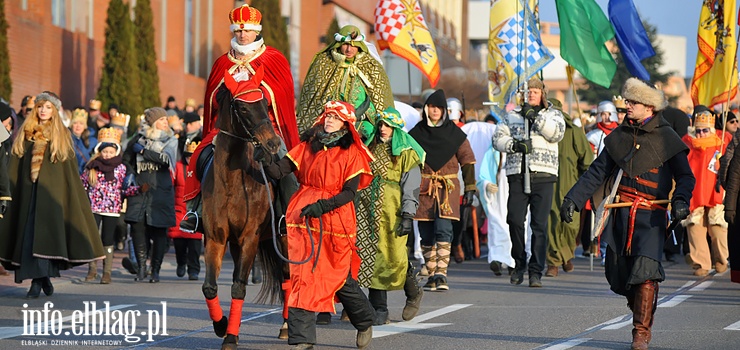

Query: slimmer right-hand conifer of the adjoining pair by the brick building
[134,0,162,108]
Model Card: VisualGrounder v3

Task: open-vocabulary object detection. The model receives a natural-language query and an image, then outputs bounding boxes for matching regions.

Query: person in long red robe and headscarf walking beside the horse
[263,101,375,349]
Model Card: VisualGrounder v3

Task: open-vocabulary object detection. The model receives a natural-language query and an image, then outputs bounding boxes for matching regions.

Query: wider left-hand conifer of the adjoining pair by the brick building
[98,0,143,123]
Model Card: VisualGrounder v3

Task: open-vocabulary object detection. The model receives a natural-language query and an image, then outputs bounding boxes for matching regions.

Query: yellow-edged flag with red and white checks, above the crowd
[375,0,439,87]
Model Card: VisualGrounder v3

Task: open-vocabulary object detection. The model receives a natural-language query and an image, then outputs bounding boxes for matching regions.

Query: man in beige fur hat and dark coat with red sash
[560,78,696,349]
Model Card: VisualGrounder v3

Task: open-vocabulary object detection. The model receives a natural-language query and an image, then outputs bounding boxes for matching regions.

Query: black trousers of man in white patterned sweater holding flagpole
[506,175,555,277]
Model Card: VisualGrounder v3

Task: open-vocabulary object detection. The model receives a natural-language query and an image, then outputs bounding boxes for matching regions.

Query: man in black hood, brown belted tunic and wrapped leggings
[409,90,477,291]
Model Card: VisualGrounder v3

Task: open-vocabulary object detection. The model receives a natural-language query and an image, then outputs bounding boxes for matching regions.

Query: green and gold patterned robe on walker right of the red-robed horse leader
[355,143,421,290]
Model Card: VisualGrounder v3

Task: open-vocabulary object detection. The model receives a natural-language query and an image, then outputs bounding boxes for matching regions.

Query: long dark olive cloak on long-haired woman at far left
[0,142,105,270]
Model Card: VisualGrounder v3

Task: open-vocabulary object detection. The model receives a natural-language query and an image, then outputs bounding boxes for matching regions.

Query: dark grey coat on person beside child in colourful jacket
[123,134,177,228]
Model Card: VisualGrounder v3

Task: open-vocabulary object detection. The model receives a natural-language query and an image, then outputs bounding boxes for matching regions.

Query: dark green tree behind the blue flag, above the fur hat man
[578,21,672,104]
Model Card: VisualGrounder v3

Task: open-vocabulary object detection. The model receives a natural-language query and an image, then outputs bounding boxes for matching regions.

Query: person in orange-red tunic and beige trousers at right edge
[682,105,732,277]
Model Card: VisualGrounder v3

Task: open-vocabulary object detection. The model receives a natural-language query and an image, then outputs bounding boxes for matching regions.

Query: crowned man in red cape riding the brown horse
[180,4,298,232]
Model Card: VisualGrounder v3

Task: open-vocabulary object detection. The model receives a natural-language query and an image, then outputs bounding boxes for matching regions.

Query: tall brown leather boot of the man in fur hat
[632,281,658,350]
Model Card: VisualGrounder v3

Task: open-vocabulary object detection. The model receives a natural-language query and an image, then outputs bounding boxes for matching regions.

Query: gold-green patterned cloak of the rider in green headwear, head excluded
[296,50,394,133]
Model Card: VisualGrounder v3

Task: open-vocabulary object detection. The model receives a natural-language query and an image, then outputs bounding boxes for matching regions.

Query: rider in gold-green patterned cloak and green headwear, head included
[296,25,394,132]
